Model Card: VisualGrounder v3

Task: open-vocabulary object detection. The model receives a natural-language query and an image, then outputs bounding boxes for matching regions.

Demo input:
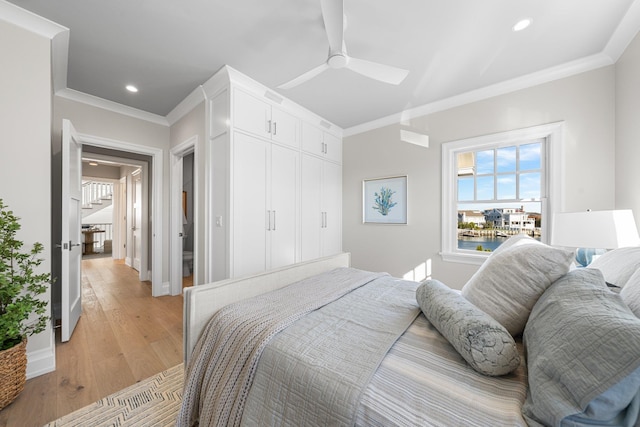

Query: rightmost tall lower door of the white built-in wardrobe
[322,162,342,256]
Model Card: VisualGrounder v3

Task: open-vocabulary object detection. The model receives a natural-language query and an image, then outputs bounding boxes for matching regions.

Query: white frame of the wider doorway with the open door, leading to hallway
[78,134,164,297]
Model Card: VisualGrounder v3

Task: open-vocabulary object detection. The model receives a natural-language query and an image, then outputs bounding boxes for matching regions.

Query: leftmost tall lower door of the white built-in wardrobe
[231,132,269,277]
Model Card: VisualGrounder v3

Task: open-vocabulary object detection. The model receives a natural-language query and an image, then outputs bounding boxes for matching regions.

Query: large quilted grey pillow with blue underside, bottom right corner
[522,268,640,427]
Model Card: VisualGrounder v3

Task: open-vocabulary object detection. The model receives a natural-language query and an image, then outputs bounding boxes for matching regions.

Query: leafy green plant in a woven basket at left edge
[0,199,51,409]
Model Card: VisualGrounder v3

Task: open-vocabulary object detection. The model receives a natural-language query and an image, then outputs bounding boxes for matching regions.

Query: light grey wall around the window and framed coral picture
[343,66,616,288]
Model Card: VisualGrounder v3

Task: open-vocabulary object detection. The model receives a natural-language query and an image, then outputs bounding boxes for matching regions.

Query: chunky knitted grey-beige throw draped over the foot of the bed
[177,268,385,426]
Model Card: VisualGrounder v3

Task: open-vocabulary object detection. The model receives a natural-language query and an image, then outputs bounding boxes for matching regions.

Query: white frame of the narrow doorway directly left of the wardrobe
[169,135,202,295]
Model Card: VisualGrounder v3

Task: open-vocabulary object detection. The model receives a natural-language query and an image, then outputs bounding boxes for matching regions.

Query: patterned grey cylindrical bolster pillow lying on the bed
[416,280,520,376]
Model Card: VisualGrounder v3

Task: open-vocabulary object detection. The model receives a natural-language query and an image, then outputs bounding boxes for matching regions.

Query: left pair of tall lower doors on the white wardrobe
[231,132,300,277]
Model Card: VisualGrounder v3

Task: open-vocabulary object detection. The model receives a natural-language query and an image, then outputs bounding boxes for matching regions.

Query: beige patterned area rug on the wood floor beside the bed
[45,364,184,427]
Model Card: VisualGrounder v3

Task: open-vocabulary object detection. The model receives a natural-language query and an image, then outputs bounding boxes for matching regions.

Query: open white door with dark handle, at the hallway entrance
[60,120,82,342]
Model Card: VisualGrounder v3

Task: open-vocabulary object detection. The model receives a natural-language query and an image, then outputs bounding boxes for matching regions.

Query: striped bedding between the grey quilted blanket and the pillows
[356,313,527,427]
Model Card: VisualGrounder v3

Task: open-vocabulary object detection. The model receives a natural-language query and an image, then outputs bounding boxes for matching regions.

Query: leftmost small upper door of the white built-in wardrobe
[233,89,271,138]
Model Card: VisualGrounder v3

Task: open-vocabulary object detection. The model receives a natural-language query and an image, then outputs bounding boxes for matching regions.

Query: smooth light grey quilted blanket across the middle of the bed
[242,276,420,427]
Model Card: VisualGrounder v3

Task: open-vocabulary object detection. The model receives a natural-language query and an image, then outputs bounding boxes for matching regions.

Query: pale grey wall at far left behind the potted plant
[0,19,55,377]
